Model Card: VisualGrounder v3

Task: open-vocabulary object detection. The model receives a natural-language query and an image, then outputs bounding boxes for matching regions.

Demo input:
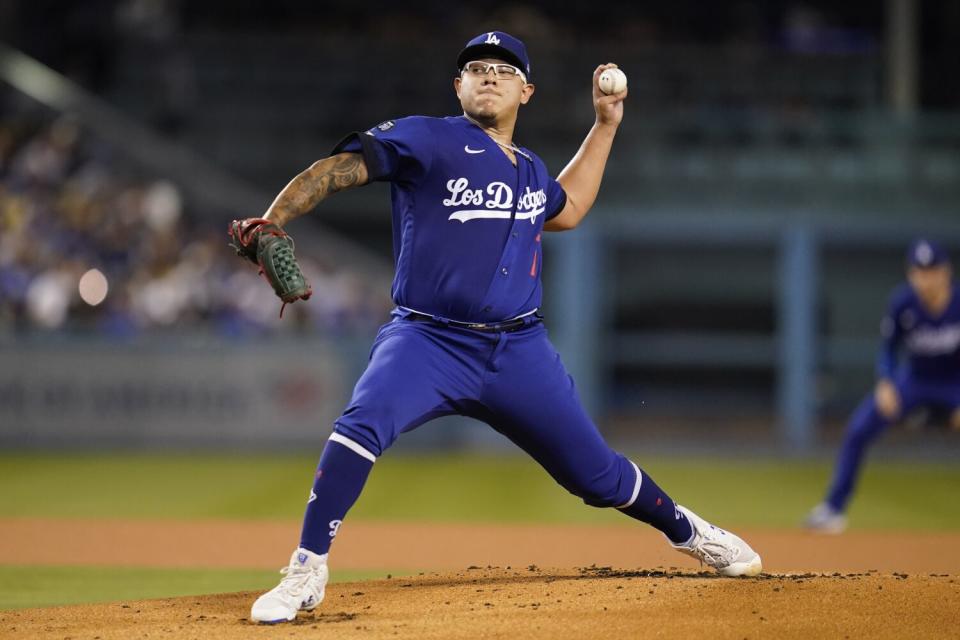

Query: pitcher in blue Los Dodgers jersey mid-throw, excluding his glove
[240,32,761,622]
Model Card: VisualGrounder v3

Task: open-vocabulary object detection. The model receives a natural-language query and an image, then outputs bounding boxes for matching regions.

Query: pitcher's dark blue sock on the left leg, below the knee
[300,433,375,554]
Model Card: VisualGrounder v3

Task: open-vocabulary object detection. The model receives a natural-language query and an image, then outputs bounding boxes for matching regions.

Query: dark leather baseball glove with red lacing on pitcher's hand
[227,218,313,318]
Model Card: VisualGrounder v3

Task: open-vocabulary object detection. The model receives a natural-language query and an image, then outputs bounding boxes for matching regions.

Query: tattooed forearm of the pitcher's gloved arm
[264,153,368,227]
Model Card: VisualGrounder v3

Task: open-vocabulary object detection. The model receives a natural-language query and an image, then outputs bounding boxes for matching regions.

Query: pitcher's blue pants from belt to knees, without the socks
[334,319,637,507]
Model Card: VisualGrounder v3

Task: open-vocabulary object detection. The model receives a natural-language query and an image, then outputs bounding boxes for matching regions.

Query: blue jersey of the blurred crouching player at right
[877,285,960,381]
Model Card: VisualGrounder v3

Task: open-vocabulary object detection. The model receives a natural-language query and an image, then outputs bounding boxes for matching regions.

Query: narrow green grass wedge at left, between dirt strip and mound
[0,566,401,610]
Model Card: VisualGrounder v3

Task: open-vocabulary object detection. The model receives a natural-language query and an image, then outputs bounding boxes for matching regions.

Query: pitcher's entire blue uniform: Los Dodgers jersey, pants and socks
[301,116,692,553]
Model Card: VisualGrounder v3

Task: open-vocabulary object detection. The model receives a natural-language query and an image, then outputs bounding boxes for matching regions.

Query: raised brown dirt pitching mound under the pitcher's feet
[0,566,960,640]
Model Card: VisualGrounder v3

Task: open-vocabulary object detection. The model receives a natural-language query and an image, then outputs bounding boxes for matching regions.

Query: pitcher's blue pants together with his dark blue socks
[301,317,693,553]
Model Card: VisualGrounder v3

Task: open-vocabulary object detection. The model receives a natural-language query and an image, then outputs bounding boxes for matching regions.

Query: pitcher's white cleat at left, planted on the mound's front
[250,549,330,624]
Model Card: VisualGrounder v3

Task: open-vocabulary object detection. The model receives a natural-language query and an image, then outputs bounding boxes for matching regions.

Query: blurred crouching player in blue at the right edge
[805,240,960,533]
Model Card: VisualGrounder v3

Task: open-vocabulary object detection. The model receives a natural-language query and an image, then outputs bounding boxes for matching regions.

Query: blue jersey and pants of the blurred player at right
[827,285,960,512]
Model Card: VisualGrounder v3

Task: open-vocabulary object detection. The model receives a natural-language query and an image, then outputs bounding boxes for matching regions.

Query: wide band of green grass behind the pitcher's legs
[0,454,960,530]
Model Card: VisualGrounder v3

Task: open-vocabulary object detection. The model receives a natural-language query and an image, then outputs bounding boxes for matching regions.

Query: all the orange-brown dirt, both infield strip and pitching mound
[0,520,960,640]
